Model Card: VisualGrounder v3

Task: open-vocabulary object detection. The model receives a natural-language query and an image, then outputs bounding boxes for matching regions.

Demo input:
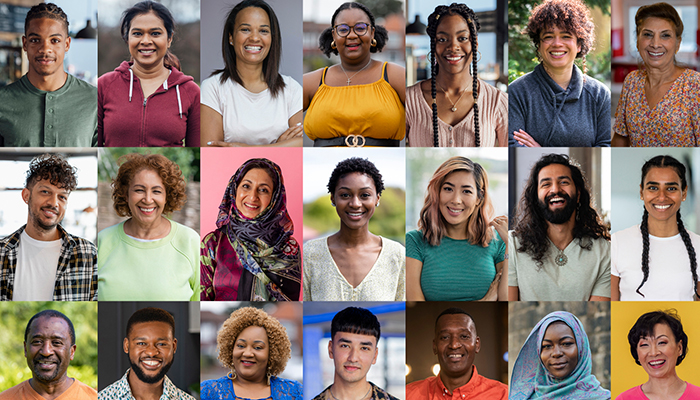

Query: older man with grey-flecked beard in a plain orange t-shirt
[0,310,97,400]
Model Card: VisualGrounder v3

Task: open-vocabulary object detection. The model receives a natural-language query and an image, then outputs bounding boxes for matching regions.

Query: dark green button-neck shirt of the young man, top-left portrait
[0,74,97,147]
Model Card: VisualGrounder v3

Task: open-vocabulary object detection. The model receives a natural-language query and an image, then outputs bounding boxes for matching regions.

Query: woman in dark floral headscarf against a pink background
[201,158,301,301]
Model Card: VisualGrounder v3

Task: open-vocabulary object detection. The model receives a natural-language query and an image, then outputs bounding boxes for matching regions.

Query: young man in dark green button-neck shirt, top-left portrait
[0,3,97,147]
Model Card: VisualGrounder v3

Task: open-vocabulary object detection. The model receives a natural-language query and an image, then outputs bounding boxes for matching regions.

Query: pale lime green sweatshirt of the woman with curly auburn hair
[97,221,199,301]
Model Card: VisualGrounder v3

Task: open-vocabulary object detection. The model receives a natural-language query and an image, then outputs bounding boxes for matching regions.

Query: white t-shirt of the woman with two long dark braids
[611,225,700,301]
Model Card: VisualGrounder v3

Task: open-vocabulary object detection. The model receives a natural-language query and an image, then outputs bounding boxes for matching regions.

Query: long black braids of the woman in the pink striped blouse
[426,3,481,147]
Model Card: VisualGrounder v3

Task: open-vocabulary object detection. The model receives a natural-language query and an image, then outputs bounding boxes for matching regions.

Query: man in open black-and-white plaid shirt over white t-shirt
[0,154,97,301]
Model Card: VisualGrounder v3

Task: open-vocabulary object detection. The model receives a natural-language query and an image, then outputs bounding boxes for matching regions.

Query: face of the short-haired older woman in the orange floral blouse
[637,17,681,68]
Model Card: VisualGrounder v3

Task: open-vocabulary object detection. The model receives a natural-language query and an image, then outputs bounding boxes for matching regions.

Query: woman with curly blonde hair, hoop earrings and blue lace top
[201,307,302,400]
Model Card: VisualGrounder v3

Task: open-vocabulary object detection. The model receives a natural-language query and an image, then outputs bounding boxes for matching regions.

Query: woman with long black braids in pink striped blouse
[406,3,508,147]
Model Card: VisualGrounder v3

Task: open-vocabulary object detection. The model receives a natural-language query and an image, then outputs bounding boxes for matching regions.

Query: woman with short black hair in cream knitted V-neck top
[302,157,406,301]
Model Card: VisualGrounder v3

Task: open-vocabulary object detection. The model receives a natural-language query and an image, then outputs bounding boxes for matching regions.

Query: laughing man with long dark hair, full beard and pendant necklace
[508,154,610,301]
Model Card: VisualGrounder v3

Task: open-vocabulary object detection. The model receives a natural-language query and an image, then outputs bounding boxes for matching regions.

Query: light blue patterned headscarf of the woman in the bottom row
[508,311,610,400]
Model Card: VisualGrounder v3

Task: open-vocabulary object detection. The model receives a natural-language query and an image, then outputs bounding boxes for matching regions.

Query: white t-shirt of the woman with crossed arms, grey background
[201,73,302,145]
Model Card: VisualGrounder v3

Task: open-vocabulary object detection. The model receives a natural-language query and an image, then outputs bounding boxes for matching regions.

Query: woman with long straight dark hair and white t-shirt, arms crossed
[201,0,302,147]
